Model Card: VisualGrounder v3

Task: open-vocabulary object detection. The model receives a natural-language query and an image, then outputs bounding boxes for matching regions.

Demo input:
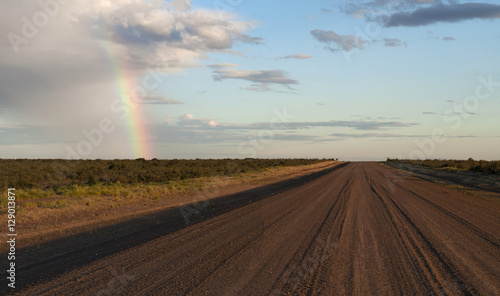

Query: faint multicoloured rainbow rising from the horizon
[96,29,153,159]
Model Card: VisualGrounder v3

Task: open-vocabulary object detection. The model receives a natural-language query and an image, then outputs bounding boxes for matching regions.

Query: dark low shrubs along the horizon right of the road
[387,158,500,174]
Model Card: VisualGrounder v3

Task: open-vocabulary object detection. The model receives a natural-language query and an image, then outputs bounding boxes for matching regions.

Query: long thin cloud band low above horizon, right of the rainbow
[150,114,417,144]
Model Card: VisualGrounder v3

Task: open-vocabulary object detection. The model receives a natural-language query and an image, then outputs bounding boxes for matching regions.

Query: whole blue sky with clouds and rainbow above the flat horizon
[0,0,500,160]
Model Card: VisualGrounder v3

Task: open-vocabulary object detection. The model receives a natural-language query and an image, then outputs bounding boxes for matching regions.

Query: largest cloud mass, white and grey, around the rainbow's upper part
[0,0,260,157]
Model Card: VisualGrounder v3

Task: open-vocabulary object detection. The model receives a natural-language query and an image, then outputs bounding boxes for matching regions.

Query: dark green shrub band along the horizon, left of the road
[0,158,332,188]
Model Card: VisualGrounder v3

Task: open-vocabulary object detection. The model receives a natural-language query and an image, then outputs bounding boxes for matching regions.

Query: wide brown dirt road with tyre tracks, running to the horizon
[9,163,500,295]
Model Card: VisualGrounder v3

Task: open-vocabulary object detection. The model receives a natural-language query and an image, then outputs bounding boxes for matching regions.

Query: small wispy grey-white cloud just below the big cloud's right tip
[211,64,298,91]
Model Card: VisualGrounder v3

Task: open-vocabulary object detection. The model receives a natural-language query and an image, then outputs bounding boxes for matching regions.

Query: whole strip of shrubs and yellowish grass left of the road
[0,158,331,210]
